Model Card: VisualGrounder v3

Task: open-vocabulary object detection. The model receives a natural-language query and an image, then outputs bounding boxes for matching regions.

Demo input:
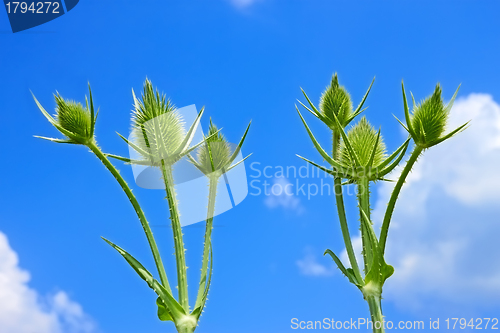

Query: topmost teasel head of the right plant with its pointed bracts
[299,73,375,135]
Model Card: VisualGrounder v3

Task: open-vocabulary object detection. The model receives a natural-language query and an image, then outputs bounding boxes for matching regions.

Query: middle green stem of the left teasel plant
[161,160,189,313]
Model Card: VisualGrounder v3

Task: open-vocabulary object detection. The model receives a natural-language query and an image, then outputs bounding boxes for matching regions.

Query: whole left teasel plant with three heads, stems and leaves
[33,79,248,333]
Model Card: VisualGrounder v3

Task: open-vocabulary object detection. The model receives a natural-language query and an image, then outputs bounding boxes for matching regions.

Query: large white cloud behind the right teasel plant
[370,94,500,308]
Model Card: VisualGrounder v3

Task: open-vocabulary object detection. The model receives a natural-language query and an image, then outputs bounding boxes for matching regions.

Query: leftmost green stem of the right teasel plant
[332,131,363,281]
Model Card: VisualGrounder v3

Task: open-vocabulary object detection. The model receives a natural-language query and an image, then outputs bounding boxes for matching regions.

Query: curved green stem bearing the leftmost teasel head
[87,142,172,294]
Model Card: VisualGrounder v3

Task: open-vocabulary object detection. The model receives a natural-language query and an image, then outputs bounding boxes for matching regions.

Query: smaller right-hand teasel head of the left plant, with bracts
[188,119,250,177]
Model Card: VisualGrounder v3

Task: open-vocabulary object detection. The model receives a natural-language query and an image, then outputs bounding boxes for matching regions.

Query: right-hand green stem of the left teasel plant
[195,174,219,309]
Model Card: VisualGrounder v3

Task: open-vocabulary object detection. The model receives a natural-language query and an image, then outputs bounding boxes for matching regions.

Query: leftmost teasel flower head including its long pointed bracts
[33,85,97,146]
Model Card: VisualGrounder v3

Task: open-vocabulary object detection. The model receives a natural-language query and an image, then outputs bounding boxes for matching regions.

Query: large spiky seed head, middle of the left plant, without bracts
[132,79,186,165]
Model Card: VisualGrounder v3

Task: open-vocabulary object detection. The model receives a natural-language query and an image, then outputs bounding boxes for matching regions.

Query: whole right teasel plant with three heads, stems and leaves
[296,74,468,333]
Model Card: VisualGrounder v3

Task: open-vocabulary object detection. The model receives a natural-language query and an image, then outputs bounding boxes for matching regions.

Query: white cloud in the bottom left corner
[0,232,96,333]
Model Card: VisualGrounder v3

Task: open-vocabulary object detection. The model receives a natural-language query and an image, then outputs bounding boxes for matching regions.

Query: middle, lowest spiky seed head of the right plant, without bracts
[340,117,386,167]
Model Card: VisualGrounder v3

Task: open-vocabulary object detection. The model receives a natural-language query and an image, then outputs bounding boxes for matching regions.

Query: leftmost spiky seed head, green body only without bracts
[55,93,94,144]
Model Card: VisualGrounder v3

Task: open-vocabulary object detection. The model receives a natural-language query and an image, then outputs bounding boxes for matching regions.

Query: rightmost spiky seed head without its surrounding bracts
[411,84,449,148]
